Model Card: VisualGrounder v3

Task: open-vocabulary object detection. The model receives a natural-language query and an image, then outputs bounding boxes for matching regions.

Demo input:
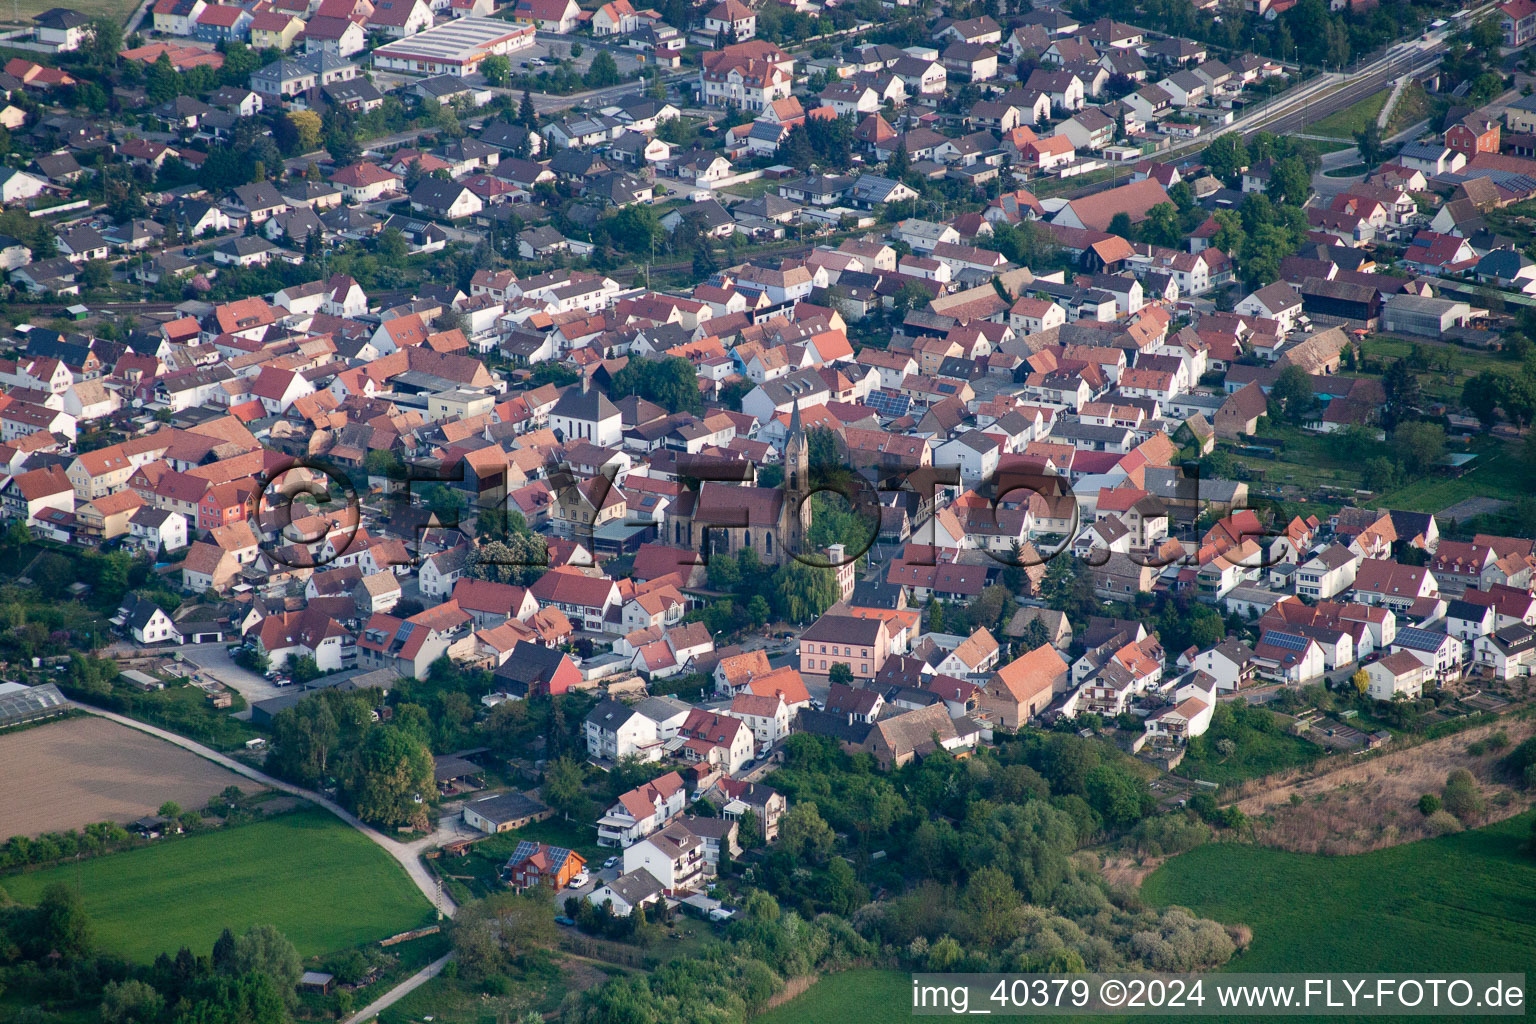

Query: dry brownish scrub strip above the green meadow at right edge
[1236,718,1536,854]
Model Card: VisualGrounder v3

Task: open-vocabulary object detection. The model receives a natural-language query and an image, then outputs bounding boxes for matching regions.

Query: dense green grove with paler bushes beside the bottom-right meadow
[757,732,1233,970]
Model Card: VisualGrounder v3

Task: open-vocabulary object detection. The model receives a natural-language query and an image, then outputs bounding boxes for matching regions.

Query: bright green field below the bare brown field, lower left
[0,809,433,963]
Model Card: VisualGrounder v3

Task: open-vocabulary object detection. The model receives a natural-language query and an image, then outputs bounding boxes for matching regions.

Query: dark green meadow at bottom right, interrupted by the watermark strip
[757,814,1536,1024]
